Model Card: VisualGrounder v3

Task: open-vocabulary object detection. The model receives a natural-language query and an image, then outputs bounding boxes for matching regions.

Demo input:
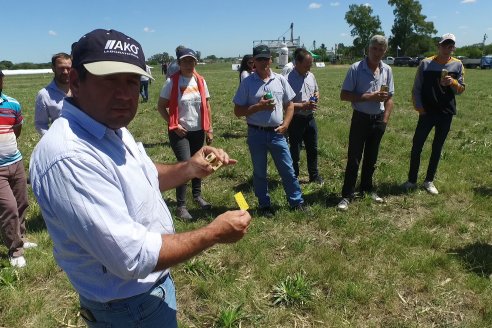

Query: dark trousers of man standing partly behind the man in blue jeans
[289,115,319,181]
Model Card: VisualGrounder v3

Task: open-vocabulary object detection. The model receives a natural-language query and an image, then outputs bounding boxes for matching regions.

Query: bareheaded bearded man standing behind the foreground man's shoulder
[34,52,72,137]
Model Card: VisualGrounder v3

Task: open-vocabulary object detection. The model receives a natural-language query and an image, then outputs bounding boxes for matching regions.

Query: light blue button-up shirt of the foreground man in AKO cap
[30,100,174,302]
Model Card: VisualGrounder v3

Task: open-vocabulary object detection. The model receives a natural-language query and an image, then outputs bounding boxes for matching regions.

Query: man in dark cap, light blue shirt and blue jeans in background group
[233,45,305,216]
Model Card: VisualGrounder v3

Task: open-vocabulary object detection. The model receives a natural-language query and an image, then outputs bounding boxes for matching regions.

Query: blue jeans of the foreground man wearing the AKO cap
[79,275,178,328]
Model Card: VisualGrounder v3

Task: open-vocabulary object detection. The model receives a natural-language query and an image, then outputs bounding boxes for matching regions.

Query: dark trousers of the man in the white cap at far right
[408,113,453,183]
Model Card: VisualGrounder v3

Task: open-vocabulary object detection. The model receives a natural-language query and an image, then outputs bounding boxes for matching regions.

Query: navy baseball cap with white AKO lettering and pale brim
[72,29,152,78]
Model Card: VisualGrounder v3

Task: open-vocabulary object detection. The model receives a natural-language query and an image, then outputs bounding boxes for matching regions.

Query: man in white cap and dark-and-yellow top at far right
[403,33,465,195]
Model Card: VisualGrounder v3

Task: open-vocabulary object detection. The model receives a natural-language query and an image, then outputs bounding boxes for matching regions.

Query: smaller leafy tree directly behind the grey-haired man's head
[345,4,383,55]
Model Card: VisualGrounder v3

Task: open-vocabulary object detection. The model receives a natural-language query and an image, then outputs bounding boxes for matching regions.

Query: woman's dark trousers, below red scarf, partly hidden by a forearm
[169,130,205,207]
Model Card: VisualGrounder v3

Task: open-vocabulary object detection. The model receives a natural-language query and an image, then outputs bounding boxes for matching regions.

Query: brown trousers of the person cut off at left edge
[0,161,28,257]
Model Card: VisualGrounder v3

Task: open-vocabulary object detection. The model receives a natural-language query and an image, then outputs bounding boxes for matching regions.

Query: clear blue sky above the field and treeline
[0,0,492,63]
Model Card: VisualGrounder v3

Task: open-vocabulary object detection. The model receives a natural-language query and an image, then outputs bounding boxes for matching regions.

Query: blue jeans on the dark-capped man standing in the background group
[248,127,304,208]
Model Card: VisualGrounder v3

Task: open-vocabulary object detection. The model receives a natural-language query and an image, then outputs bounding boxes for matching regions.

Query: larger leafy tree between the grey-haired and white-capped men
[388,0,437,56]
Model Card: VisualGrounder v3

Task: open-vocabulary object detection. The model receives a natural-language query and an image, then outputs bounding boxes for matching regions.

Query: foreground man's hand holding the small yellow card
[205,210,251,243]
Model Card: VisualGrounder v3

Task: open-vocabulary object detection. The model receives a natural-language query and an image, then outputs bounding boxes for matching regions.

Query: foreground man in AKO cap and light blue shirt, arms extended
[30,29,251,327]
